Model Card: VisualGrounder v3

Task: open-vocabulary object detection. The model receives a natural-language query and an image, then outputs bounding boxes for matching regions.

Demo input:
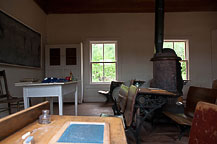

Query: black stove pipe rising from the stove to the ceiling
[155,0,164,53]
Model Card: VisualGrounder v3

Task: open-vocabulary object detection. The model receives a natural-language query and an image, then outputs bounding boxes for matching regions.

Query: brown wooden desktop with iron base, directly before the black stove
[138,88,177,96]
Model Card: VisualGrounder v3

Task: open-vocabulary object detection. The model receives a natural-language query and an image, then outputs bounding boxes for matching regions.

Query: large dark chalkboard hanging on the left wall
[0,11,41,68]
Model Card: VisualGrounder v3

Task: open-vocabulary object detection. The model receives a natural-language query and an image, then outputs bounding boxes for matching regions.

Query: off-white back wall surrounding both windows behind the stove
[47,12,217,101]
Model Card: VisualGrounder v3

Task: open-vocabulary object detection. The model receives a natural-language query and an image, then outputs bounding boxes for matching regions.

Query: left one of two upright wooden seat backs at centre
[116,84,129,114]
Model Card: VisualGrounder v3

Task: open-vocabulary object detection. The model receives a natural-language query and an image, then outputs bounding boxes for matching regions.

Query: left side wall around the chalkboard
[0,0,47,116]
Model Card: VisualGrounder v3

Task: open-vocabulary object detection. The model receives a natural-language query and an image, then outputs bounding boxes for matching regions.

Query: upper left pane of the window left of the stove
[92,44,103,62]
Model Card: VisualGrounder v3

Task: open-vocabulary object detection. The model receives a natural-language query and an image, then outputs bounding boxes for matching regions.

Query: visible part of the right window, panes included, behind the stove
[163,40,189,80]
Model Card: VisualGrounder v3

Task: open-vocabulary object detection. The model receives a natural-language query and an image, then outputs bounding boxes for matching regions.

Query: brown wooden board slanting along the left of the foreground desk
[0,101,49,140]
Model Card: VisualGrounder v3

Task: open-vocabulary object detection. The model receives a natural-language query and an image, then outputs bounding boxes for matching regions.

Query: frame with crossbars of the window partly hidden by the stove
[164,39,190,80]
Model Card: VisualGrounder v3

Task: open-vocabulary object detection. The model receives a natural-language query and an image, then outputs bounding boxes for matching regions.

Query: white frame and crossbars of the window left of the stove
[89,40,118,84]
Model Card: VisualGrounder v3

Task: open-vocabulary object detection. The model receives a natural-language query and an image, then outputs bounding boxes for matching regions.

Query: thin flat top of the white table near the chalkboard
[15,81,78,87]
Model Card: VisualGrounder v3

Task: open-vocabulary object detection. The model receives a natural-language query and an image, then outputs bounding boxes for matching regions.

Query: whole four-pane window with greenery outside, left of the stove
[90,41,117,83]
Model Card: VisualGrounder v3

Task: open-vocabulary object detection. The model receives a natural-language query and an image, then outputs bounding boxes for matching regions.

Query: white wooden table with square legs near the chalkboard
[15,81,78,116]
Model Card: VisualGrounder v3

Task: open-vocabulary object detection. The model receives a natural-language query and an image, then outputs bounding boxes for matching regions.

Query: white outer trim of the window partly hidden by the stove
[164,39,190,80]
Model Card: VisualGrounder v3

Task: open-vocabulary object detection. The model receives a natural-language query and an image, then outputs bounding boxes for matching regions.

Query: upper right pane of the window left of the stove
[104,44,115,62]
